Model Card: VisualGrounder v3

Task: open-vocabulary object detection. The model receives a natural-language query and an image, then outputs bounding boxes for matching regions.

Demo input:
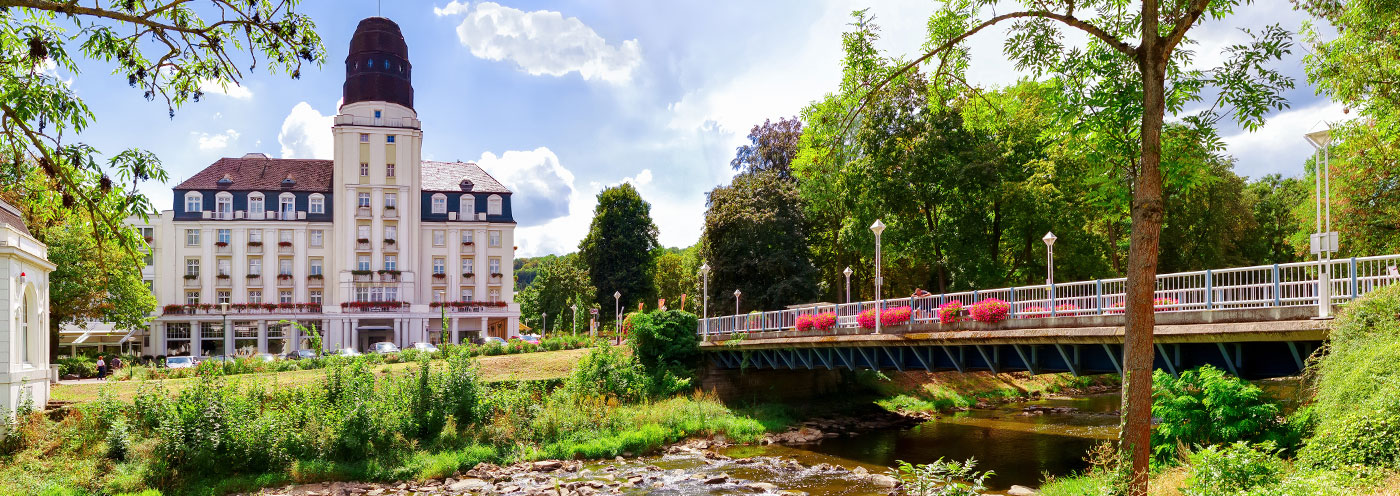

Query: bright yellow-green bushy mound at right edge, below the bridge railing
[1299,286,1400,468]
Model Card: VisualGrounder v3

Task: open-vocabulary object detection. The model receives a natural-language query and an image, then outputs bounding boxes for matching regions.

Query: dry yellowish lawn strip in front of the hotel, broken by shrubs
[50,347,588,404]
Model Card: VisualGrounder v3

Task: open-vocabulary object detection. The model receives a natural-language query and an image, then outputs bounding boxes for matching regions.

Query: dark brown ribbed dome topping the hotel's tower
[344,17,413,109]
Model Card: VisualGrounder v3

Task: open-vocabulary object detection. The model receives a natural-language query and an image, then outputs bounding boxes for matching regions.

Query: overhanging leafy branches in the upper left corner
[0,0,325,252]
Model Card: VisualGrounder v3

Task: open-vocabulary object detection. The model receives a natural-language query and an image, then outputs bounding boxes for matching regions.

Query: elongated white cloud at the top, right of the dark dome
[433,1,641,83]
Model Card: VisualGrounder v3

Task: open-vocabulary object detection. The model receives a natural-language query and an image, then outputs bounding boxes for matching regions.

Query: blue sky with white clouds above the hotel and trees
[65,0,1345,256]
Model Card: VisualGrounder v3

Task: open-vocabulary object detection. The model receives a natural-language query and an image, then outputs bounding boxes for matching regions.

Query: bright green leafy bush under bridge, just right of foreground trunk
[1152,366,1281,462]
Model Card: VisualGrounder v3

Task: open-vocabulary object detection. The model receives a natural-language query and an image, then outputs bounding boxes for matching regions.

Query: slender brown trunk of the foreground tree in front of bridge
[1119,0,1166,496]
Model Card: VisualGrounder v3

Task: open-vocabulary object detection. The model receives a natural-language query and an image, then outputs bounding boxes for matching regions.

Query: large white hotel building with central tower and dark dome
[137,17,519,356]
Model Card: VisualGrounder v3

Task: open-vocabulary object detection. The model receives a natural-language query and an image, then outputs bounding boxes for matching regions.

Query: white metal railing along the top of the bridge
[697,255,1400,333]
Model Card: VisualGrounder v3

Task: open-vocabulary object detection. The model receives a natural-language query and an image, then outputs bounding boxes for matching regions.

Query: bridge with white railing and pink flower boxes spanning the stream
[699,255,1400,378]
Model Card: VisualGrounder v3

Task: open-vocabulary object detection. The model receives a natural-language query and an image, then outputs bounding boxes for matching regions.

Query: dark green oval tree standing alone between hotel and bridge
[578,182,658,315]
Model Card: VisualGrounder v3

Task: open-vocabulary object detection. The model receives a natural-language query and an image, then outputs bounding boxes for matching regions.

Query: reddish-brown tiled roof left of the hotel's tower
[175,154,335,192]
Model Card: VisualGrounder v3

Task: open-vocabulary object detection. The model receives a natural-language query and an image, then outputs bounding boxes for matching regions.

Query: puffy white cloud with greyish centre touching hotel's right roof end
[476,147,574,226]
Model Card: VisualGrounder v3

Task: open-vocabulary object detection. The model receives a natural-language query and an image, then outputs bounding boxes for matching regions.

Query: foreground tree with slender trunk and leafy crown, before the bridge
[853,0,1292,496]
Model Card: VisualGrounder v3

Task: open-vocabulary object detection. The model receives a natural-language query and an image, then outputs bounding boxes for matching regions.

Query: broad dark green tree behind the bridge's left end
[701,171,819,311]
